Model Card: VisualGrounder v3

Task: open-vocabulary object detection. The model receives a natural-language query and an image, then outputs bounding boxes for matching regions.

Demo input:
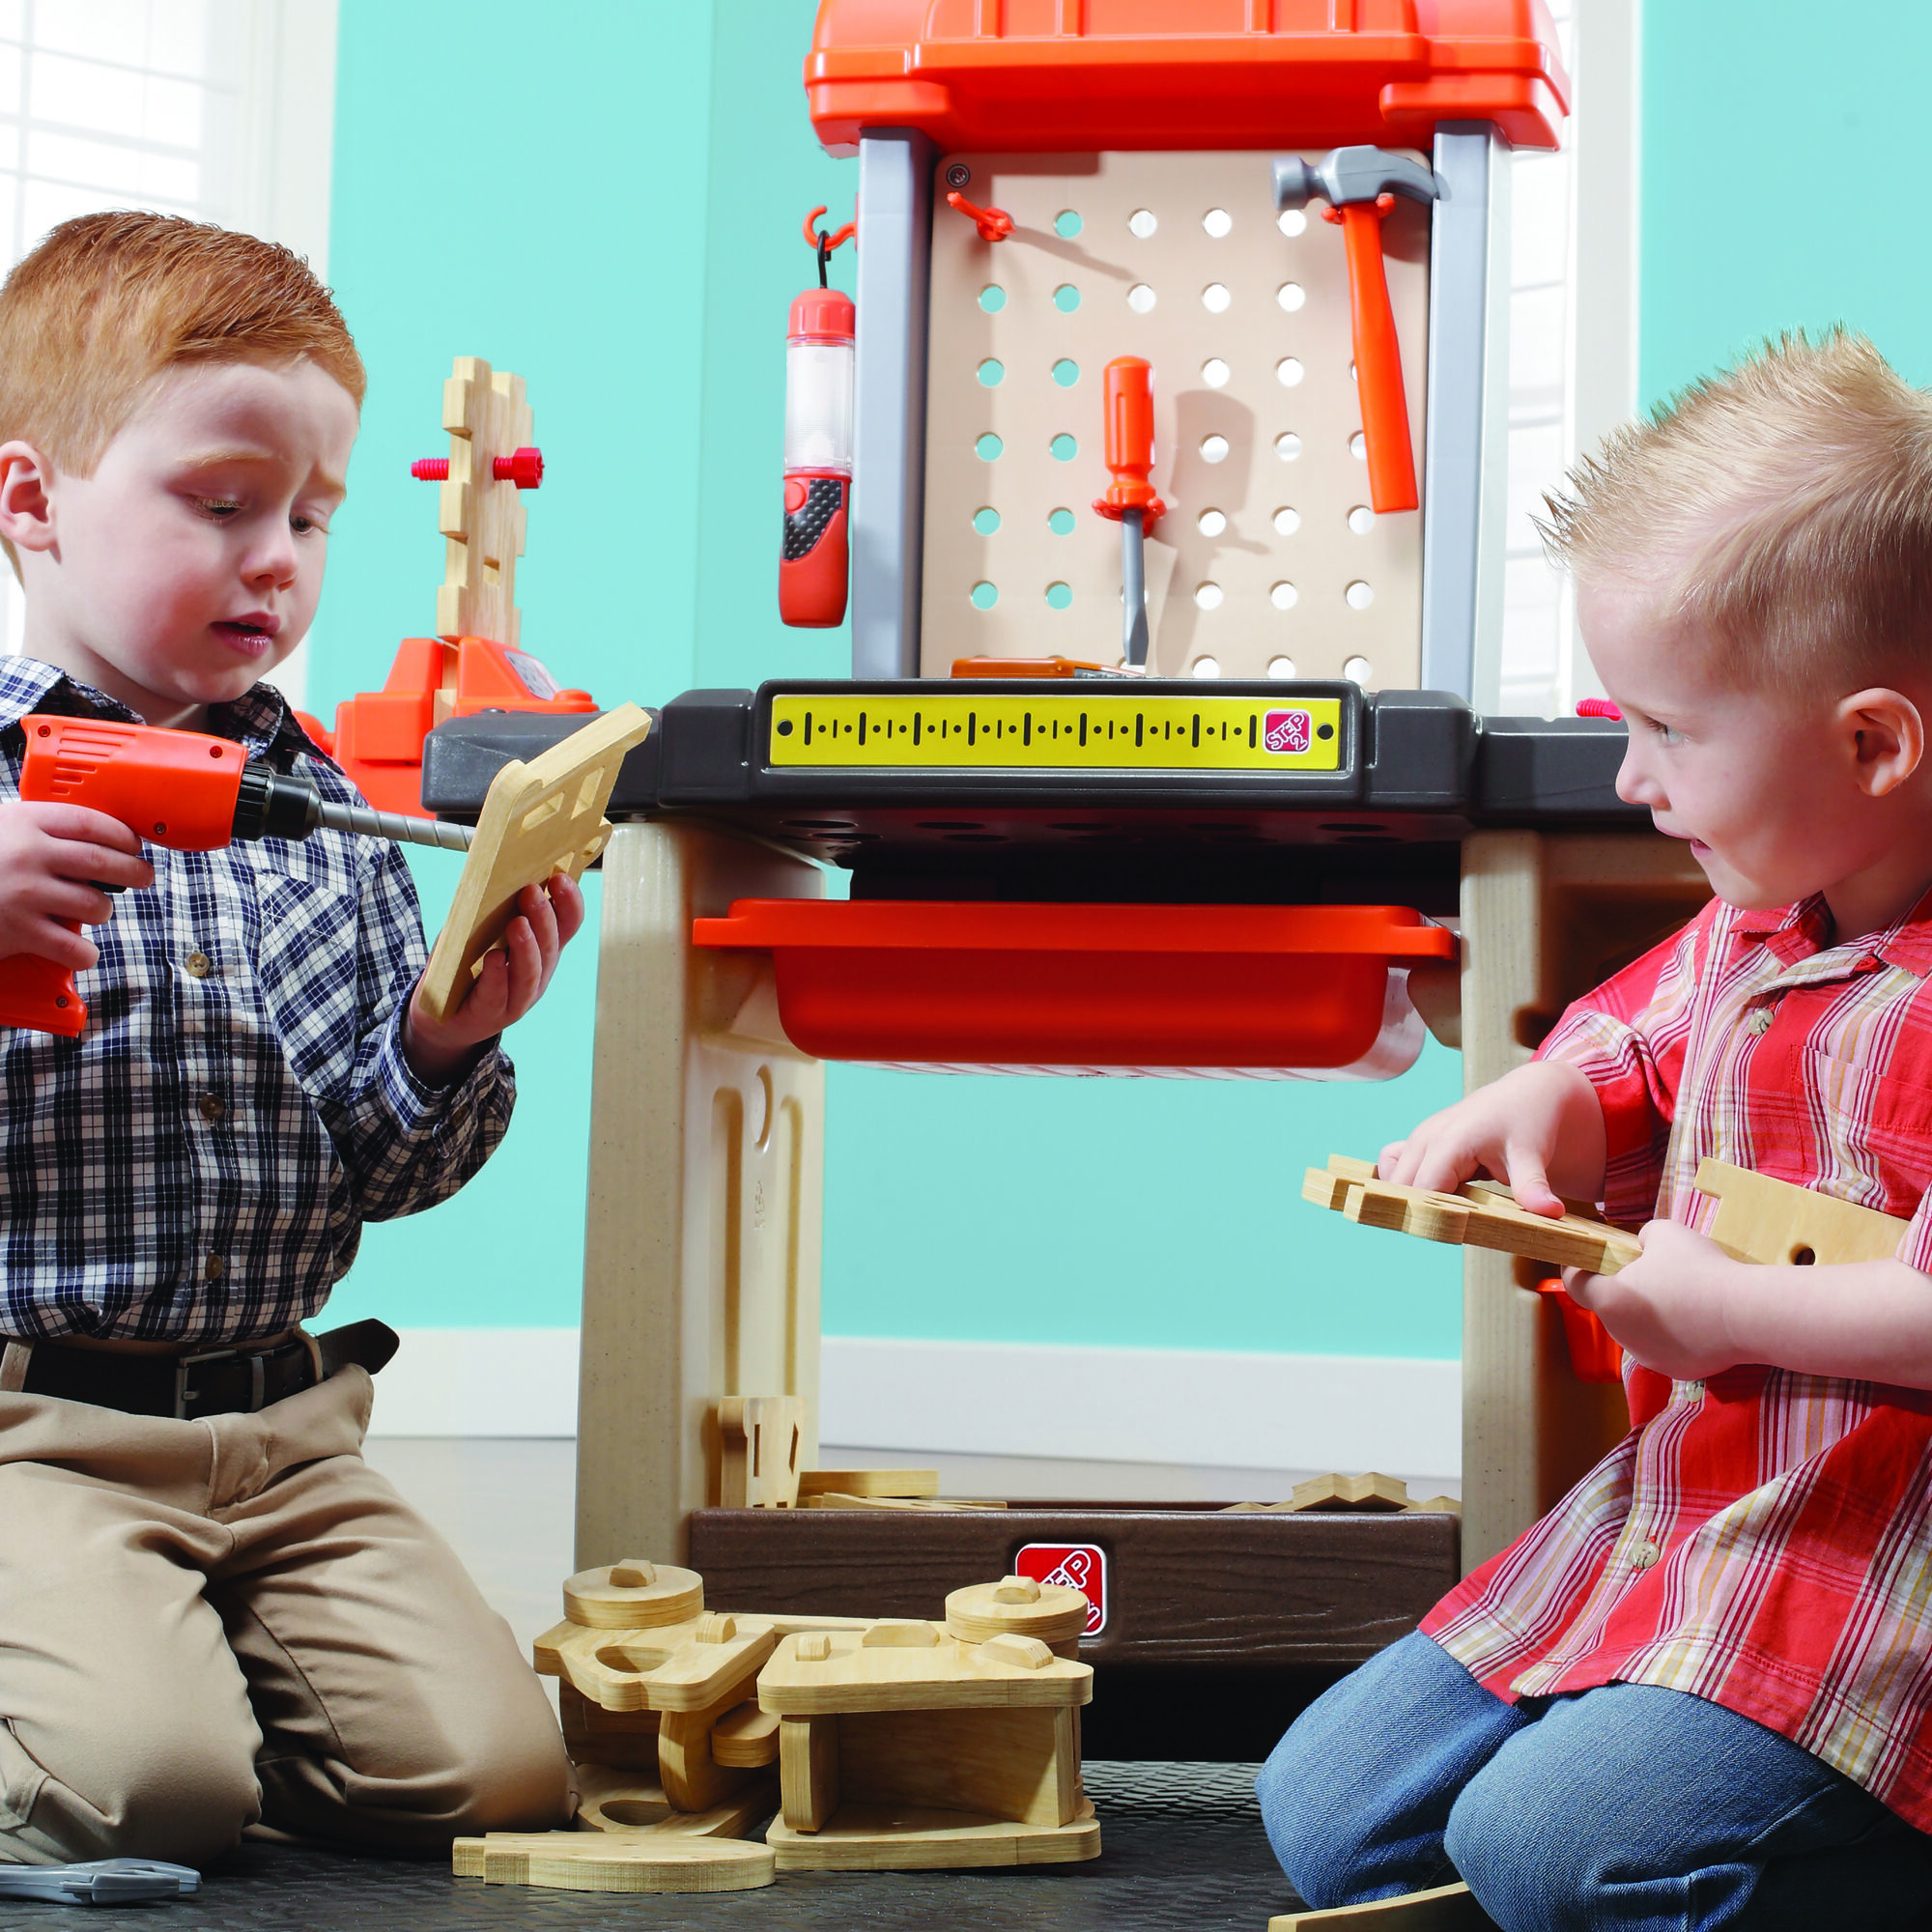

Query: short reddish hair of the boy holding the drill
[0,209,369,477]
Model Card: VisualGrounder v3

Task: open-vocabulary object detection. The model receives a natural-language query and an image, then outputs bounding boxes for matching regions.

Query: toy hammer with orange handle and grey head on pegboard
[1275,147,1435,516]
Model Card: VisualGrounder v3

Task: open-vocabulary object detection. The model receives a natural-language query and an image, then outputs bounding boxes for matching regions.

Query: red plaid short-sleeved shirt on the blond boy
[1422,895,1932,1832]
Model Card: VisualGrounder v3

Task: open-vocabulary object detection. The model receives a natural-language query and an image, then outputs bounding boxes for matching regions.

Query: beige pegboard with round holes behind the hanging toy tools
[920,151,1430,688]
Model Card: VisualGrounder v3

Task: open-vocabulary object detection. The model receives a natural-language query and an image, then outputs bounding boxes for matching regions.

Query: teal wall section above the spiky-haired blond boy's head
[1640,0,1932,402]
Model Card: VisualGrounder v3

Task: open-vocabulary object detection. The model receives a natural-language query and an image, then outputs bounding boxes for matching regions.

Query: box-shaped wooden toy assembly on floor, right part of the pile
[757,1615,1099,1870]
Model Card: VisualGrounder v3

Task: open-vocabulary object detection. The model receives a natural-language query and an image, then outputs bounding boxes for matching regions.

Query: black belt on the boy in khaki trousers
[10,1321,398,1422]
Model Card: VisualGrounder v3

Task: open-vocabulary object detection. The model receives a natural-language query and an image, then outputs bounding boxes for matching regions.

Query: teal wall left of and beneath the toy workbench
[311,0,1461,1356]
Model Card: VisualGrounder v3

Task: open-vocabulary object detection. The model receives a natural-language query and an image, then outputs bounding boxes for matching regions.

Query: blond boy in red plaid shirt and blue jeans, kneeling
[1260,334,1932,1932]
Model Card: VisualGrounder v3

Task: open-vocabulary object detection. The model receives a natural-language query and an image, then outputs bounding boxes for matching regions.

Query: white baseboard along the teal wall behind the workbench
[371,1329,1463,1478]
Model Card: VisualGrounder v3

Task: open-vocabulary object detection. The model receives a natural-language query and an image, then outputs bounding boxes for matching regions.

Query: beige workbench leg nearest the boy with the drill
[576,823,825,1569]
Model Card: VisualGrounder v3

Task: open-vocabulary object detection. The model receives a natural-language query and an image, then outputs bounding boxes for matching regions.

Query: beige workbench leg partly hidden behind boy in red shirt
[1463,831,1710,1571]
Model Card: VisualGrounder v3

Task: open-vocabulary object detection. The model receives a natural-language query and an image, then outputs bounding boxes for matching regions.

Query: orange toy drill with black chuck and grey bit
[0,715,473,1039]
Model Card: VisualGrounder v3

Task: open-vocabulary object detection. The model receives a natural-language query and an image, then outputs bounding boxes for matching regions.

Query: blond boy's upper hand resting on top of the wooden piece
[1378,1061,1604,1219]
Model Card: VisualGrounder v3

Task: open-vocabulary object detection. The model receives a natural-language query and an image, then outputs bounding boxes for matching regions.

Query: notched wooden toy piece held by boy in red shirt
[1302,1153,1907,1275]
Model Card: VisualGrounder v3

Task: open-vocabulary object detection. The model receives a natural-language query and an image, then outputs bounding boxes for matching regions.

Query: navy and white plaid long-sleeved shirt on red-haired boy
[0,657,516,1345]
